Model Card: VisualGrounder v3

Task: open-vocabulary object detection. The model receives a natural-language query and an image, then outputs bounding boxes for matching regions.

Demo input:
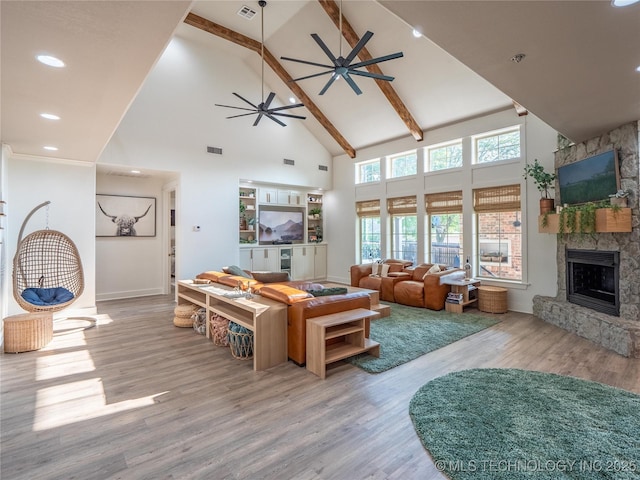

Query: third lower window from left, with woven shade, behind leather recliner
[424,190,464,267]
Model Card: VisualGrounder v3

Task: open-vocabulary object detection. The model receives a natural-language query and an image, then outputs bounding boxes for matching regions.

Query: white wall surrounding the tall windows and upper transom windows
[325,110,557,312]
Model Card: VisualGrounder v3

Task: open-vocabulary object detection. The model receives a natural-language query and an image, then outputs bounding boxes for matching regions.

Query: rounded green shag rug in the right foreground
[409,369,640,480]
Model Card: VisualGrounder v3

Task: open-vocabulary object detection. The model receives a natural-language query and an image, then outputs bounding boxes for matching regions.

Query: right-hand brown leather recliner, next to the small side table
[394,263,464,310]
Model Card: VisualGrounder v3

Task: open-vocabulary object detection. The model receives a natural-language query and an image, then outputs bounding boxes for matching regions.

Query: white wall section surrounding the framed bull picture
[96,174,175,301]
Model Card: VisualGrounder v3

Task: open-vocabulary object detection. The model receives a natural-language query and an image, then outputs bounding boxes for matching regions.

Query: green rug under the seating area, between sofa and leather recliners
[346,303,499,373]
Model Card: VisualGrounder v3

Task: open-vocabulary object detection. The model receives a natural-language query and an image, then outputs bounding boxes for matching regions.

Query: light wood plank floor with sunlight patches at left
[0,296,640,480]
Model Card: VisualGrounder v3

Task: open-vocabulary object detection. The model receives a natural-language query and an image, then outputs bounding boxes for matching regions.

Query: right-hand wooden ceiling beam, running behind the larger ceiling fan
[318,0,423,141]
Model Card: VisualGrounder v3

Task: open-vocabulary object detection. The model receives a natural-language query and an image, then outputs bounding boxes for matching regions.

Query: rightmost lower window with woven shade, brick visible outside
[473,185,522,280]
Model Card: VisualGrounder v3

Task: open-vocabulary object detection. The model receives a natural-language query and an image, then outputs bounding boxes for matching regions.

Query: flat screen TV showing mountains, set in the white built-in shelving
[258,205,304,245]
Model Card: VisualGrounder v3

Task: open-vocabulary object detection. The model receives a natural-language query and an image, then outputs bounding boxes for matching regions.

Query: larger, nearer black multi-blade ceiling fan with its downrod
[280,0,403,95]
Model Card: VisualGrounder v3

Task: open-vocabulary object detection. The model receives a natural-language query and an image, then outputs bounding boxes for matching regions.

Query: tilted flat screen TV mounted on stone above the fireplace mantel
[558,150,620,205]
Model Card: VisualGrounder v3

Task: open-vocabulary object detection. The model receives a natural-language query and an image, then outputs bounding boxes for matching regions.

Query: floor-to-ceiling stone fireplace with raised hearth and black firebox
[533,122,640,358]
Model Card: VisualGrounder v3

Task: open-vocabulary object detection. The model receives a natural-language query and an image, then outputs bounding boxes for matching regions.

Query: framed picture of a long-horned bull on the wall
[96,194,156,237]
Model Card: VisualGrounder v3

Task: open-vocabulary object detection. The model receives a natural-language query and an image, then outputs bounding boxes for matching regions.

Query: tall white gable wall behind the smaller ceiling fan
[98,32,331,279]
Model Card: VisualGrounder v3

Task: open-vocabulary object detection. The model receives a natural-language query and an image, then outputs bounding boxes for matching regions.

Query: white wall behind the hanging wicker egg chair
[2,156,96,315]
